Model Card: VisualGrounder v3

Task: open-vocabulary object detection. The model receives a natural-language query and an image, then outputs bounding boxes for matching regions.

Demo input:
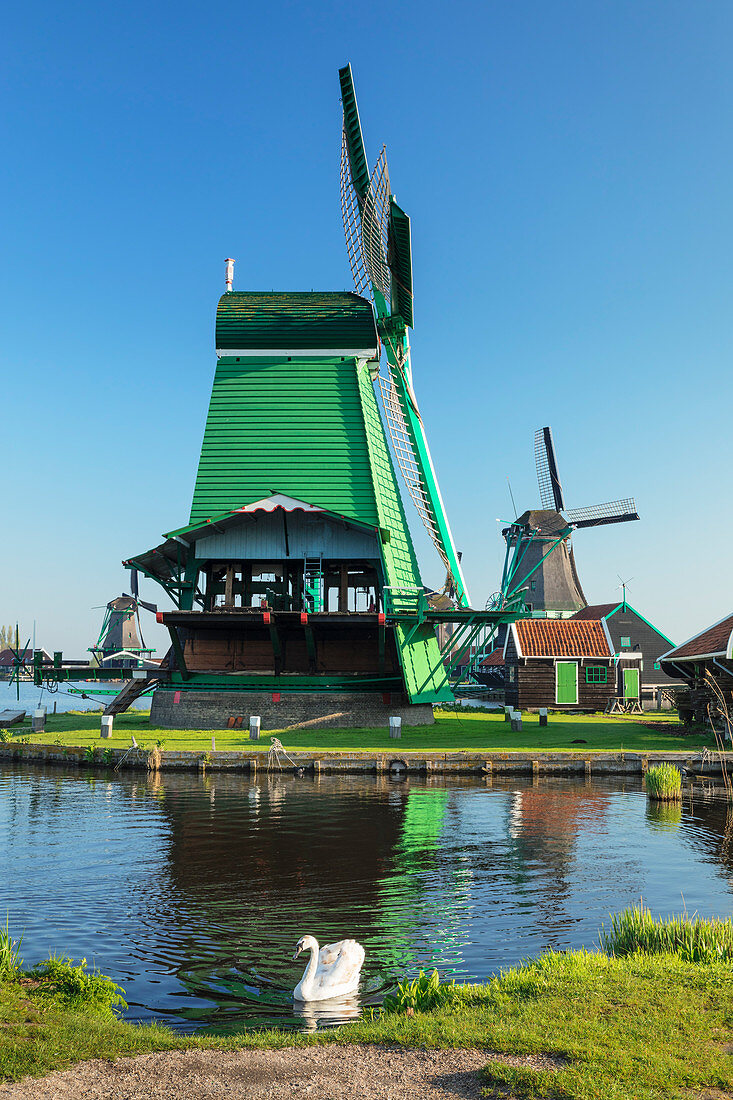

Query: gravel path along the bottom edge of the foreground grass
[0,1043,549,1100]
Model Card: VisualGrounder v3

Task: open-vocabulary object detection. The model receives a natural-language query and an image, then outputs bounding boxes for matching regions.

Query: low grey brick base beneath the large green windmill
[150,689,435,729]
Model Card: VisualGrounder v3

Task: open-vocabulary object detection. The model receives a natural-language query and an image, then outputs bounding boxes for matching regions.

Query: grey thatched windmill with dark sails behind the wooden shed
[502,427,639,613]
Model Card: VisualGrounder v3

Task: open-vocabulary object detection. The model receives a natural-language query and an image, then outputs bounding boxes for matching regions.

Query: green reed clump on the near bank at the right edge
[600,903,733,963]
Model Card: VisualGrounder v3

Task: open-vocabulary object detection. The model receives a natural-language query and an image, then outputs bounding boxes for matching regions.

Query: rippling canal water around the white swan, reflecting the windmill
[0,765,733,1032]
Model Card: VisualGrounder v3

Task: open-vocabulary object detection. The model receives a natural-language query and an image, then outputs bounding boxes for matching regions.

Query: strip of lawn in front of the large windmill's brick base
[4,711,715,754]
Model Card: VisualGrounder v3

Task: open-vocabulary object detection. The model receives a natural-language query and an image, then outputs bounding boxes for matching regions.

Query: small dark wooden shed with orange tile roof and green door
[504,618,619,711]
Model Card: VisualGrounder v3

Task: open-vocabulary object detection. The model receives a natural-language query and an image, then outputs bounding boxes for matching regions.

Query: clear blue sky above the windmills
[0,0,733,656]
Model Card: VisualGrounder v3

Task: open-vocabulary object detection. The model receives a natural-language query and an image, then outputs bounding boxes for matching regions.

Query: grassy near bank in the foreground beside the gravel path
[0,952,733,1100]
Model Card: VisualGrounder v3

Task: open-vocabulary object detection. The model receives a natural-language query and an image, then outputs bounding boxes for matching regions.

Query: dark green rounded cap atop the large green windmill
[216,290,379,356]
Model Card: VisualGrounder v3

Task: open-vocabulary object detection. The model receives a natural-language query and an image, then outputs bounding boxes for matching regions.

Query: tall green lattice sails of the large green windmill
[339,65,469,606]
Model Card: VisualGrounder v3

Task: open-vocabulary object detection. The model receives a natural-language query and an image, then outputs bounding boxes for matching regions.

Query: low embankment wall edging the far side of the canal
[0,741,721,779]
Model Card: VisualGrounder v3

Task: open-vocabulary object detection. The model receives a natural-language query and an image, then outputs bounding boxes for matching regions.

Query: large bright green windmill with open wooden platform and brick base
[35,66,522,729]
